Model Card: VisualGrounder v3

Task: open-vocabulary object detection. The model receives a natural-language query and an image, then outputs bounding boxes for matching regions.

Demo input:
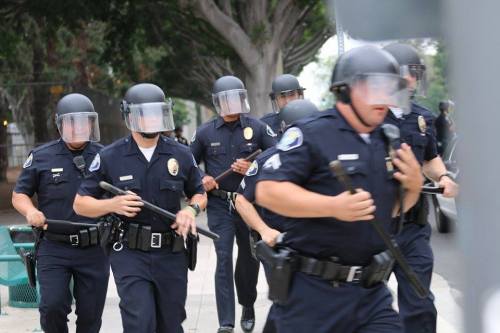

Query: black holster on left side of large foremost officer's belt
[255,240,297,304]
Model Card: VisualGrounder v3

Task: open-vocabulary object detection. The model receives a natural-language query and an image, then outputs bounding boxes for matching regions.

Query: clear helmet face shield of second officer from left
[123,99,175,133]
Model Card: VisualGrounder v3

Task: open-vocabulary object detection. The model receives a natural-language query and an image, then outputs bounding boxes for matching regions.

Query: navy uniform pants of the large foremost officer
[273,273,403,333]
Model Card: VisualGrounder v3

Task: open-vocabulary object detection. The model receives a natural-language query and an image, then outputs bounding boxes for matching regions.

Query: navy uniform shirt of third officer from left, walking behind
[191,115,276,192]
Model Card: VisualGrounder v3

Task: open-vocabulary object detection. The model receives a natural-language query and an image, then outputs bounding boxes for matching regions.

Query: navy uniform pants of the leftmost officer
[37,239,109,333]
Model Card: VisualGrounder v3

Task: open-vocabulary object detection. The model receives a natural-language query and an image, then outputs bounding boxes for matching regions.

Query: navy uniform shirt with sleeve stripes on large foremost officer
[258,109,398,265]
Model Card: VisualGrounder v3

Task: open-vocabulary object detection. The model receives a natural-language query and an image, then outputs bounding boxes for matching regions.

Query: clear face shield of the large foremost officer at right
[349,74,410,114]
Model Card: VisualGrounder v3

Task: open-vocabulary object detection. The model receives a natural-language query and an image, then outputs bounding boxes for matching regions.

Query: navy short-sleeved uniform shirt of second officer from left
[78,136,204,232]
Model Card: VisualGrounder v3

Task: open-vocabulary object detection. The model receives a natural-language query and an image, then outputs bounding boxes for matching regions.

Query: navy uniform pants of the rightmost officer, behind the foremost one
[394,223,437,333]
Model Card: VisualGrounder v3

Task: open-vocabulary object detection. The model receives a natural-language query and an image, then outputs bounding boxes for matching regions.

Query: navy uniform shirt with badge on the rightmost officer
[385,102,438,164]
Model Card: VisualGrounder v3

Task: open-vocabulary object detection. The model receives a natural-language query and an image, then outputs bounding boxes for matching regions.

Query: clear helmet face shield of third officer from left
[212,89,250,117]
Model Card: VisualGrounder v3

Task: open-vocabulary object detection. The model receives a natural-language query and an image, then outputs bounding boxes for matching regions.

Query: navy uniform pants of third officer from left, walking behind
[207,196,259,327]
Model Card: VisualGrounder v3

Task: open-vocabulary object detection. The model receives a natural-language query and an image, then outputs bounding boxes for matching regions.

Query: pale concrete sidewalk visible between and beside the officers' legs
[0,214,461,333]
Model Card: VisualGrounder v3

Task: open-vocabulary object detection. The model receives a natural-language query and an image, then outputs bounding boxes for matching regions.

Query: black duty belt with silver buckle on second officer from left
[125,223,184,252]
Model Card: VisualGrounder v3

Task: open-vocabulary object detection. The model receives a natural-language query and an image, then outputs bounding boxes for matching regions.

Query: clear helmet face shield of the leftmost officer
[56,112,101,143]
